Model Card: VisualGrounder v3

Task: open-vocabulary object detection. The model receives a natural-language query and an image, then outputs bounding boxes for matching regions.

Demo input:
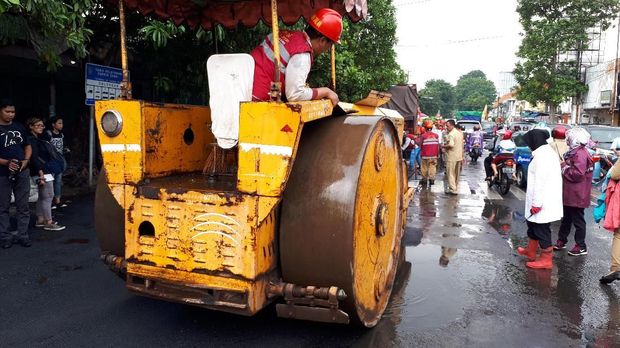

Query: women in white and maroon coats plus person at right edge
[517,126,620,283]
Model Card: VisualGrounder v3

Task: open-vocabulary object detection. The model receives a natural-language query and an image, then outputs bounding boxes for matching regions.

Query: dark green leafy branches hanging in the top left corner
[0,0,95,71]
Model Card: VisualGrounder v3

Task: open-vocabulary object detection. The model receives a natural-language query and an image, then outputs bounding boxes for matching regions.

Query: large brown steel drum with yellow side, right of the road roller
[279,116,404,327]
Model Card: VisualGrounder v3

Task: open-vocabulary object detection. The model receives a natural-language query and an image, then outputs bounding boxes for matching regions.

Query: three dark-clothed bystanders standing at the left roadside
[0,99,66,249]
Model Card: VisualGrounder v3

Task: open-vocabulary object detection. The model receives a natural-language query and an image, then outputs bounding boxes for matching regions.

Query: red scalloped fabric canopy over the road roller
[120,0,367,30]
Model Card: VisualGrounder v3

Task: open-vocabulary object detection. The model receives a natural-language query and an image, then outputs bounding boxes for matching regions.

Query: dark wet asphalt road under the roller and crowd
[0,158,620,347]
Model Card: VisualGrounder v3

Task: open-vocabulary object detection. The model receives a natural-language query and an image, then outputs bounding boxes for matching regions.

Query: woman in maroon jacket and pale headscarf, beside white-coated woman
[553,128,594,256]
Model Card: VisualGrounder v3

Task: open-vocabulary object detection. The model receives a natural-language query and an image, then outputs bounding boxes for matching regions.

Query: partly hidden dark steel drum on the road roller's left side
[95,169,125,257]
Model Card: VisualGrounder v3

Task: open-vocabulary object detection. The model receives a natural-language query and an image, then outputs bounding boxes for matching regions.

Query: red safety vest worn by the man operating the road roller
[250,31,314,101]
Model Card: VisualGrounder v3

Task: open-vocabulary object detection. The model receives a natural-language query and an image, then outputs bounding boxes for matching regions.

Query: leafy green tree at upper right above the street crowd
[514,0,620,113]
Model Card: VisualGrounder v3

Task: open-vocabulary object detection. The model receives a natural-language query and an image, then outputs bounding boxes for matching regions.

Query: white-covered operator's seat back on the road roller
[207,53,254,149]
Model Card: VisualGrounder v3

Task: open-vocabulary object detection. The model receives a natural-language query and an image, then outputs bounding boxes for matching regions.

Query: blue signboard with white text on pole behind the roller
[85,63,123,105]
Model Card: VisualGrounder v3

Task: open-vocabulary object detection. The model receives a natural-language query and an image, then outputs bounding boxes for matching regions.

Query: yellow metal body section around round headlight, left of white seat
[95,100,215,184]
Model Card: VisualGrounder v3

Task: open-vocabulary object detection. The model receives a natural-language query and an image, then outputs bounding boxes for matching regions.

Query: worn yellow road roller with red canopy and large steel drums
[95,0,412,327]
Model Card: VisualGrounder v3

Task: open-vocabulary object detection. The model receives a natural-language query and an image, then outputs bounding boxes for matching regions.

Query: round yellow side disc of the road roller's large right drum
[352,119,404,326]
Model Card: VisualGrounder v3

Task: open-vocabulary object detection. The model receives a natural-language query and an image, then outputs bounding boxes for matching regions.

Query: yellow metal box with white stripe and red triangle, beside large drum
[237,100,332,197]
